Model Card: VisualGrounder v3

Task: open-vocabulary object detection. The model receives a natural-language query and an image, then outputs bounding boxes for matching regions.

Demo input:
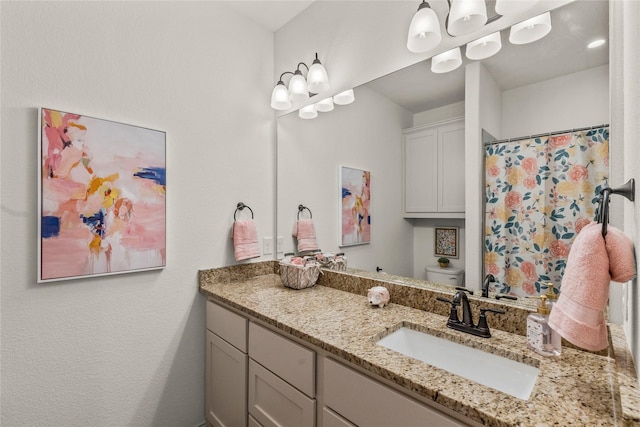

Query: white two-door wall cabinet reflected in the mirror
[403,118,465,218]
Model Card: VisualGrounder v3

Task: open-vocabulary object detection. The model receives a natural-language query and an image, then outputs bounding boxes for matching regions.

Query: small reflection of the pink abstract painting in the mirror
[340,166,371,246]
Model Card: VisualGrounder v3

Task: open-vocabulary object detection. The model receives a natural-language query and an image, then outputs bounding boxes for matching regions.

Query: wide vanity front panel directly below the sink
[324,359,463,427]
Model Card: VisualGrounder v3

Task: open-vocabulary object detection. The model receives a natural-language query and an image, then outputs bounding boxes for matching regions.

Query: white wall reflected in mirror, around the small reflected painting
[278,86,413,276]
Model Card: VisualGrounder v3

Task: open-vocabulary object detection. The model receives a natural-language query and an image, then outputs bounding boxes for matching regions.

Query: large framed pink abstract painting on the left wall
[38,108,166,283]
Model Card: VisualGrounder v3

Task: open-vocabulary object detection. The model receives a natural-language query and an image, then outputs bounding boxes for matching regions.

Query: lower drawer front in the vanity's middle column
[249,359,316,427]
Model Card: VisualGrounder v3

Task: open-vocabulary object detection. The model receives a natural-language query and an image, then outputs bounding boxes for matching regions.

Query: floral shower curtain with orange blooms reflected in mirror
[484,126,609,297]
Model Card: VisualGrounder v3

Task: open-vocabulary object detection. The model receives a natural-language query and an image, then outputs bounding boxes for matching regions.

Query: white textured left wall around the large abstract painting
[0,1,275,427]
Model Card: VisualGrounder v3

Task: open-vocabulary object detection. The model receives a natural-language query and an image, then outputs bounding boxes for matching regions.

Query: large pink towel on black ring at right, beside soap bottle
[549,222,636,351]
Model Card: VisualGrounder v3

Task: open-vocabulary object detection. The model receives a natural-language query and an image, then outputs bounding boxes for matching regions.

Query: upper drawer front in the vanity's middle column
[249,322,316,397]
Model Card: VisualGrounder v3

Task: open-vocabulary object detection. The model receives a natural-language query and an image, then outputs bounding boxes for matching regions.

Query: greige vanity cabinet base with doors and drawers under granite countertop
[206,301,467,427]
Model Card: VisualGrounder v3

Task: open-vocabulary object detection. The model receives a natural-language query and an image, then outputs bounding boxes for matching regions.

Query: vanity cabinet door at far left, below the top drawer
[205,331,248,427]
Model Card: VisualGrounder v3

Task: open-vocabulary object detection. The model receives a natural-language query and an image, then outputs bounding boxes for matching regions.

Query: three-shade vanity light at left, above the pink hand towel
[271,53,329,110]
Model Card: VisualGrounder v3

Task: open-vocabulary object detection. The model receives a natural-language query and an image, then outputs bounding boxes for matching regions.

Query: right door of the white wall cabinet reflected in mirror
[438,120,465,212]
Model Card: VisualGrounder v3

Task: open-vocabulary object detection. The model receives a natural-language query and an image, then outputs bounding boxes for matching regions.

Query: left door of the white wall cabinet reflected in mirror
[404,128,438,213]
